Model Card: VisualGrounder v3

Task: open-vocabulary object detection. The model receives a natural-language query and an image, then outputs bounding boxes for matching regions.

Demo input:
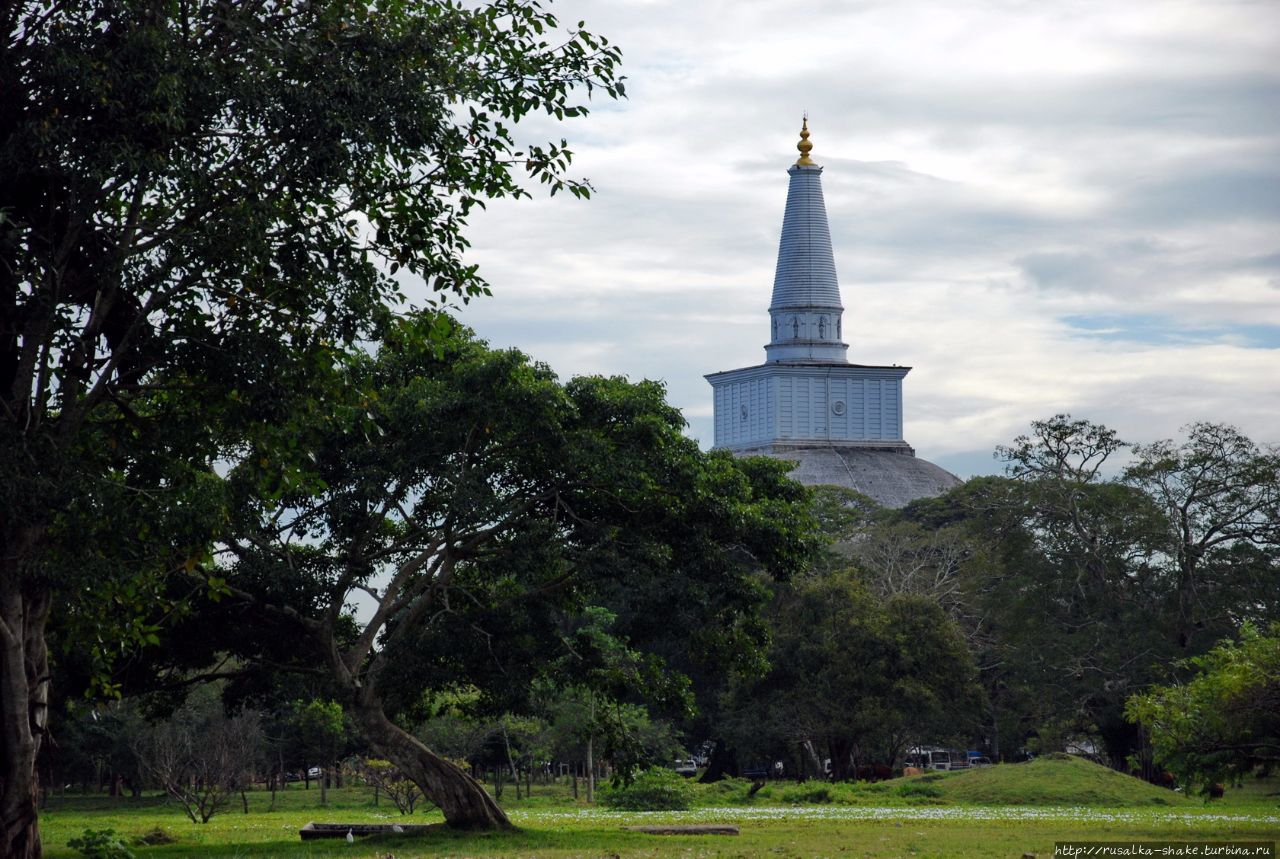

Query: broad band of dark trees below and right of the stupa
[699,415,1280,778]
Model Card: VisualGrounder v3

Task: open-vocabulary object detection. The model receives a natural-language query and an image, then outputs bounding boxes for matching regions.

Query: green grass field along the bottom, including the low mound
[42,760,1280,859]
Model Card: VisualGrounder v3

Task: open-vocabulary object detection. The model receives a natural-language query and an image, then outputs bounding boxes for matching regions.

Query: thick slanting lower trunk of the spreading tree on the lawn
[353,700,515,830]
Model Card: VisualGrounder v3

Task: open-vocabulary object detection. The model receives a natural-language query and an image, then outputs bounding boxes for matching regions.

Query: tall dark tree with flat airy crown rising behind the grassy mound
[973,415,1169,767]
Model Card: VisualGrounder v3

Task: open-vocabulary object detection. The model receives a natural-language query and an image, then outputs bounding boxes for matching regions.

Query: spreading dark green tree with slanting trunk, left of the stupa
[199,320,809,827]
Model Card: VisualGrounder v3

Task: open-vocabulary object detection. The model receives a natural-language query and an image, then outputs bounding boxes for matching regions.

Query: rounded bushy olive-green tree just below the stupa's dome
[731,570,980,780]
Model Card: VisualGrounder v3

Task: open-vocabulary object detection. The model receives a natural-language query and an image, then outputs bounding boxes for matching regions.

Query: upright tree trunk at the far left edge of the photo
[0,570,50,859]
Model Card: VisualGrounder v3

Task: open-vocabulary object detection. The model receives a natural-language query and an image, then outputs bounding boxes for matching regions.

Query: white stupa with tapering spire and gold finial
[707,119,960,507]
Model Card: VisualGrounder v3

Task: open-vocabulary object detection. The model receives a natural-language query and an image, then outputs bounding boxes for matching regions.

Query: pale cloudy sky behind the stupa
[422,0,1280,476]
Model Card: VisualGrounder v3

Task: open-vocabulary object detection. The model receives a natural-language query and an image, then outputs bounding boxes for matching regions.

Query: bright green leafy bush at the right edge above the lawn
[1125,623,1280,791]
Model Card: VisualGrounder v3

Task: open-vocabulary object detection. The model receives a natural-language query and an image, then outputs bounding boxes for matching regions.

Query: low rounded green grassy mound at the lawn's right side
[913,755,1197,808]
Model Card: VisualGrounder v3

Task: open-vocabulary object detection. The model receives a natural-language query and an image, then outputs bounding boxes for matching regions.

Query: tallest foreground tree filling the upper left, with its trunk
[0,0,622,856]
